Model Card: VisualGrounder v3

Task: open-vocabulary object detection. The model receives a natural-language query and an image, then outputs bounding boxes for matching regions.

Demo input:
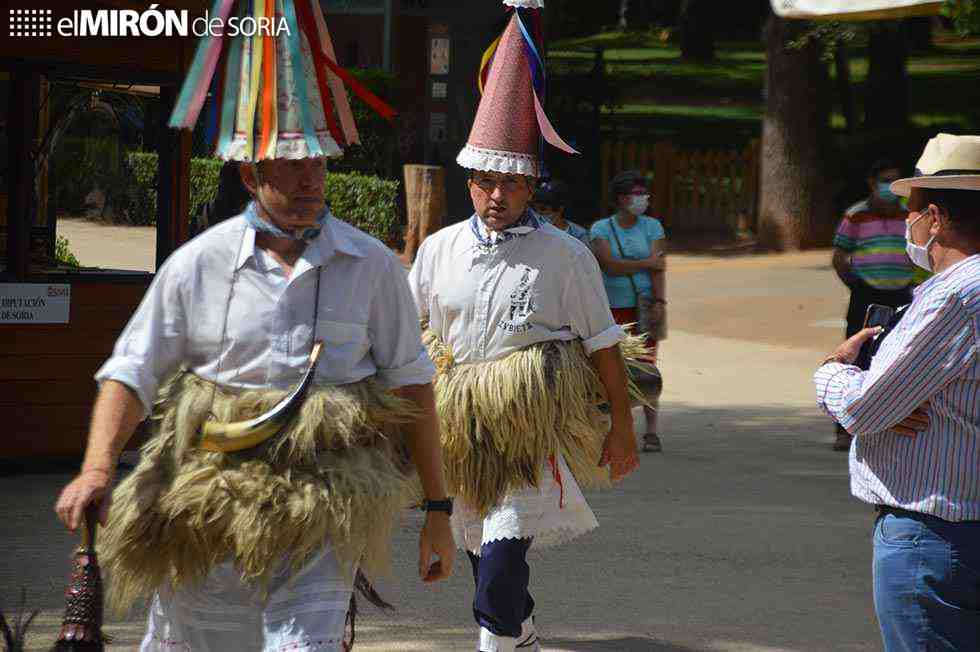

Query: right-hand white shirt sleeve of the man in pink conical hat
[563,250,626,355]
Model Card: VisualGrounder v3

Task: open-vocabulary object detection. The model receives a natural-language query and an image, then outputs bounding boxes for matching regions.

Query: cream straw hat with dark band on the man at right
[891,134,980,197]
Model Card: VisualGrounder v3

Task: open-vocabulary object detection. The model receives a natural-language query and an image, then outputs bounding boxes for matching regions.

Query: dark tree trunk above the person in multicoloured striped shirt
[864,20,909,129]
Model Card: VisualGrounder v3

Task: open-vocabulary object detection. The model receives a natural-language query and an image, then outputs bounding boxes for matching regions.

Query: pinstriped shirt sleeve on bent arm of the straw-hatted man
[814,295,978,435]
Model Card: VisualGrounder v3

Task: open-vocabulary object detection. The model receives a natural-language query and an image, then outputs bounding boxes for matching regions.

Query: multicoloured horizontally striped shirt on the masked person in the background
[834,200,913,290]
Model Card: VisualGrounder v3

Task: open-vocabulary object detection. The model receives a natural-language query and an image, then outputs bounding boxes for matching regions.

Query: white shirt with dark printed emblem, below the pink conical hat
[409,218,625,363]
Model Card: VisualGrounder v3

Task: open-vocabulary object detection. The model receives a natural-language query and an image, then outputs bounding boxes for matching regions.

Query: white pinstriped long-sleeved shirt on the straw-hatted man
[814,254,980,521]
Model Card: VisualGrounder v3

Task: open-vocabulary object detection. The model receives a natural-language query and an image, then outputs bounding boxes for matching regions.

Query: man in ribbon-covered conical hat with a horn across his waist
[56,0,455,652]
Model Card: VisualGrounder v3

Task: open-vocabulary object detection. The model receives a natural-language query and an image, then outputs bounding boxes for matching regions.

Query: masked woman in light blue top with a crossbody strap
[590,171,667,452]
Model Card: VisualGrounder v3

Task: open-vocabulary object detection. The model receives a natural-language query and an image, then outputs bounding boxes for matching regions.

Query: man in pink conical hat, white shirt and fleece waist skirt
[409,0,638,652]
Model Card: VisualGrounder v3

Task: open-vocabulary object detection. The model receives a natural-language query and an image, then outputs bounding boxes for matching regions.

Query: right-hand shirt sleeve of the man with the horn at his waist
[368,255,435,389]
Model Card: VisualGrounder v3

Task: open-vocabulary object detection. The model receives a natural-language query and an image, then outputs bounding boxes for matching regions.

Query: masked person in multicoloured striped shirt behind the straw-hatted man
[833,159,914,451]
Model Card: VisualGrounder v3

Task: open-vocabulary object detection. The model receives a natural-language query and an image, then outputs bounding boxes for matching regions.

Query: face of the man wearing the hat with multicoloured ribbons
[242,158,327,230]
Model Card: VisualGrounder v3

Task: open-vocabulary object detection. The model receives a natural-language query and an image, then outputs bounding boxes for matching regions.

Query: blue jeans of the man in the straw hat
[873,511,980,652]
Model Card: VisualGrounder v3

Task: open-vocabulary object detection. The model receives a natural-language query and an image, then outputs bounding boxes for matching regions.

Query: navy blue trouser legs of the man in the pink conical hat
[468,539,534,638]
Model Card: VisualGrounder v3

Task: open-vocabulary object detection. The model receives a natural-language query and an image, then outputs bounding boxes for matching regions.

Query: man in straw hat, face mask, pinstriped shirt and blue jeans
[815,134,980,651]
